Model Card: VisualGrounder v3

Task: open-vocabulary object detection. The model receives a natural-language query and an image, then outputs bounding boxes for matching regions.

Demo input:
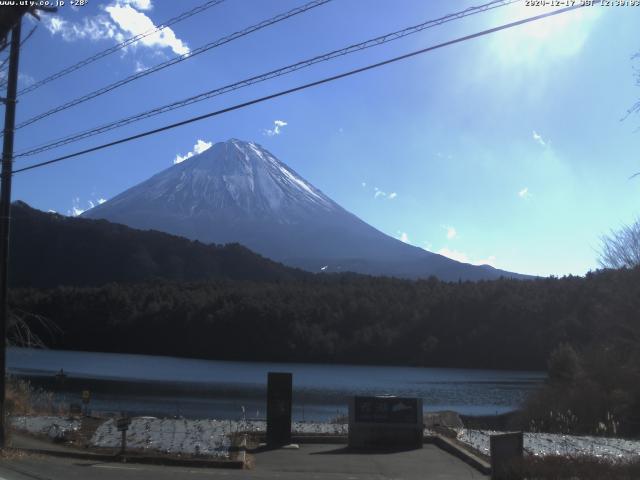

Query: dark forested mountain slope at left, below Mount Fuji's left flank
[9,202,302,287]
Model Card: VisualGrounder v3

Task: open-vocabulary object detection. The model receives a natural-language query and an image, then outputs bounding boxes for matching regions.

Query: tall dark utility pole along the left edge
[0,19,22,448]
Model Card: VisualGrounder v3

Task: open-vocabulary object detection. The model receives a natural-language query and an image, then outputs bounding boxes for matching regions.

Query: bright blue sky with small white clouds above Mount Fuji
[7,0,640,275]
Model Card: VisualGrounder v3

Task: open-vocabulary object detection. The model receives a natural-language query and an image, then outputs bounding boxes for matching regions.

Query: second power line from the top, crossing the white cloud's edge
[16,0,332,130]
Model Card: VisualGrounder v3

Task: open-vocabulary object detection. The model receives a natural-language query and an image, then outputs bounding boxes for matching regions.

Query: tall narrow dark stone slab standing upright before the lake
[267,372,293,447]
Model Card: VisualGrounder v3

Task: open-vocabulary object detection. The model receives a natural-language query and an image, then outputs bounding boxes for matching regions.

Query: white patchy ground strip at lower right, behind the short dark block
[458,429,640,460]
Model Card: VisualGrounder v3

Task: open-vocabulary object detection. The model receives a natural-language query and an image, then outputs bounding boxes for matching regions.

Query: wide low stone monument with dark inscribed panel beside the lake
[349,396,424,449]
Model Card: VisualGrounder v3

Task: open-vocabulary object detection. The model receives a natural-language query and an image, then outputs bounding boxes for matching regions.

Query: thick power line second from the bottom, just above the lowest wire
[16,0,521,158]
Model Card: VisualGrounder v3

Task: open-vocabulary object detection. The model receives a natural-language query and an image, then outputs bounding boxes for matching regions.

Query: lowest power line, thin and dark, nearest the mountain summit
[13,0,599,173]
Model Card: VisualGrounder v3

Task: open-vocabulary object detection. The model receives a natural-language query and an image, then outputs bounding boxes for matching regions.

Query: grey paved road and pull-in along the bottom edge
[0,445,488,480]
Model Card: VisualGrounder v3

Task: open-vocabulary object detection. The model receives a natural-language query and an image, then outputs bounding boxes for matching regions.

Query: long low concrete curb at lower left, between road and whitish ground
[12,448,246,470]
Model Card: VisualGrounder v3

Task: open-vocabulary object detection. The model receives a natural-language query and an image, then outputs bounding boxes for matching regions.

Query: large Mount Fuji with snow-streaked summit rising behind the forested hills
[82,139,530,280]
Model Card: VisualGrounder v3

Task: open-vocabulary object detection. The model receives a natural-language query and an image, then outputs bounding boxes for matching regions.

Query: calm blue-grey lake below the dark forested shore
[7,348,546,420]
